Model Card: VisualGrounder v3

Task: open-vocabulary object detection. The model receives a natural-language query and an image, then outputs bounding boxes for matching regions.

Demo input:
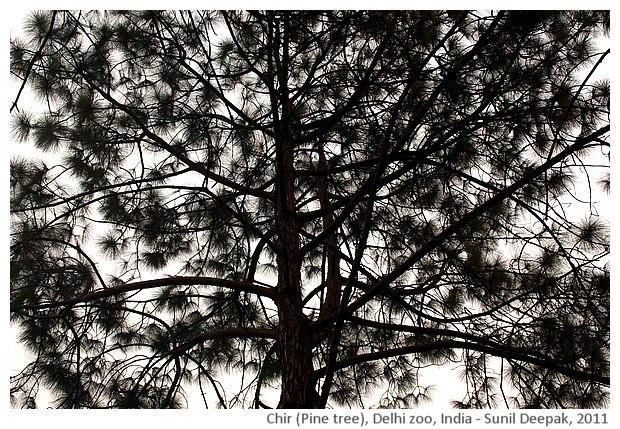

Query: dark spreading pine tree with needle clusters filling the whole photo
[10,11,610,408]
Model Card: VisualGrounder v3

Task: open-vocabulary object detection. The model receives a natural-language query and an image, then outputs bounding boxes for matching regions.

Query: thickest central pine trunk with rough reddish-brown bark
[269,13,318,408]
